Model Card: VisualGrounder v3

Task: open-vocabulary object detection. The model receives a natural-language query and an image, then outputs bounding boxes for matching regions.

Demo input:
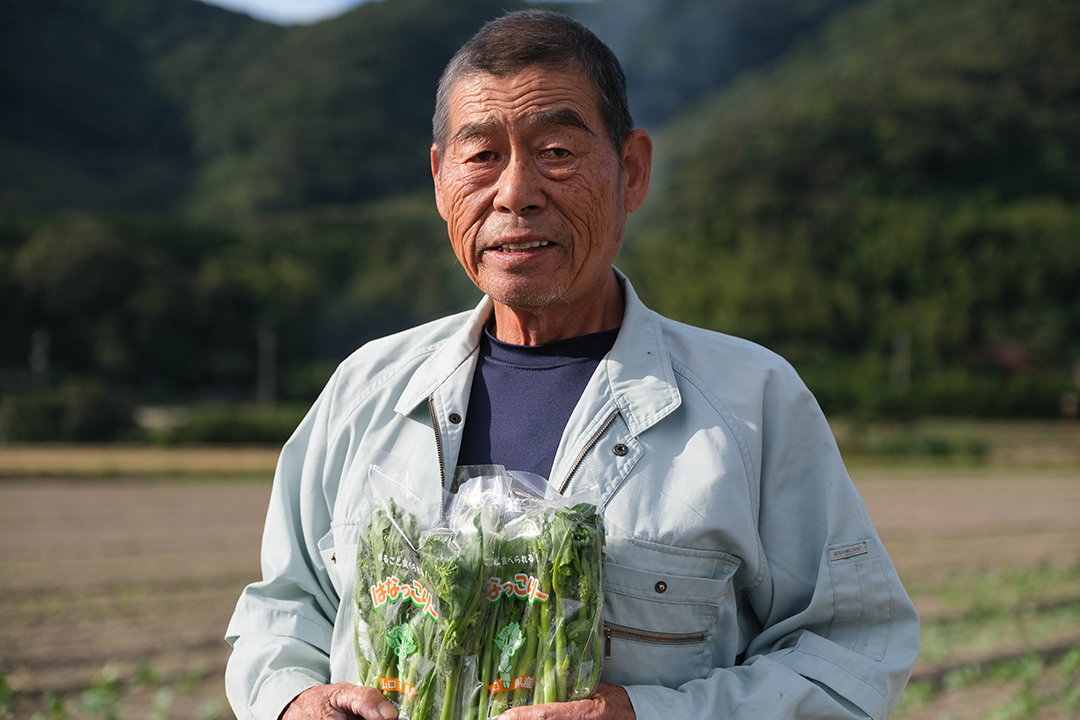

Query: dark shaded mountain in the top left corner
[0,0,261,210]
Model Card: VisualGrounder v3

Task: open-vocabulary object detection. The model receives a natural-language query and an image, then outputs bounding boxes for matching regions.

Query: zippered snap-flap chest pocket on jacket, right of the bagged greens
[602,563,738,688]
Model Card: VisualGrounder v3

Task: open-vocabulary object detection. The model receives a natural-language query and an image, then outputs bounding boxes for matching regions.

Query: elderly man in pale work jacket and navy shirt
[227,11,918,720]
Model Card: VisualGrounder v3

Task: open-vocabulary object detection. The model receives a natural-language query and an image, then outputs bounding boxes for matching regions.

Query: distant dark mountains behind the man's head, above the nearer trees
[0,0,868,218]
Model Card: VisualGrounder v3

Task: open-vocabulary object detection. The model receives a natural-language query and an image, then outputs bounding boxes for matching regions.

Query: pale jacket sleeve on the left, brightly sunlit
[225,388,338,720]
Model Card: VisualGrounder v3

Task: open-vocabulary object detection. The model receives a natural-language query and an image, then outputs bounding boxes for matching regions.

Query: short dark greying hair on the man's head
[431,10,634,157]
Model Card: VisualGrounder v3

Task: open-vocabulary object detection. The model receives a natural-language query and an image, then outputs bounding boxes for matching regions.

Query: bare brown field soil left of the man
[0,479,270,718]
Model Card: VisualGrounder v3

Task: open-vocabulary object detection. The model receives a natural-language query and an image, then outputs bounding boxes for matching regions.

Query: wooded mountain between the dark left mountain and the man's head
[184,0,527,213]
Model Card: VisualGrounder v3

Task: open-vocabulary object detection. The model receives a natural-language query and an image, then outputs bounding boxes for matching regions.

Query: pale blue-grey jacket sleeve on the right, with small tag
[627,364,919,720]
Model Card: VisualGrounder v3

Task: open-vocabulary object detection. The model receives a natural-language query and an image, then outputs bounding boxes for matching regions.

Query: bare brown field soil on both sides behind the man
[0,470,1080,718]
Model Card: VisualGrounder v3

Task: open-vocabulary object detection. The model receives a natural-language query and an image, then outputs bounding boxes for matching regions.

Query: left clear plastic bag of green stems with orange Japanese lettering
[353,459,483,719]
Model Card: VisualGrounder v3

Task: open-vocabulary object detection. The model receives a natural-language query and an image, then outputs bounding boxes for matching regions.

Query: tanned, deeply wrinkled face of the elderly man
[432,68,651,310]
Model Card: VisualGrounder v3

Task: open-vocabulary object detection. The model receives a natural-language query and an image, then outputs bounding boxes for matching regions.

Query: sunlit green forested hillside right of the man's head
[633,0,1080,412]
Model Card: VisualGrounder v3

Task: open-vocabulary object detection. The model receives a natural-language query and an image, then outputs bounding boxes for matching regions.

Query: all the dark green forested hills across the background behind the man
[0,0,1080,434]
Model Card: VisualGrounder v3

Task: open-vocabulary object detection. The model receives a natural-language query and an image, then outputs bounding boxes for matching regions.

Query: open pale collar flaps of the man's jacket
[394,264,681,436]
